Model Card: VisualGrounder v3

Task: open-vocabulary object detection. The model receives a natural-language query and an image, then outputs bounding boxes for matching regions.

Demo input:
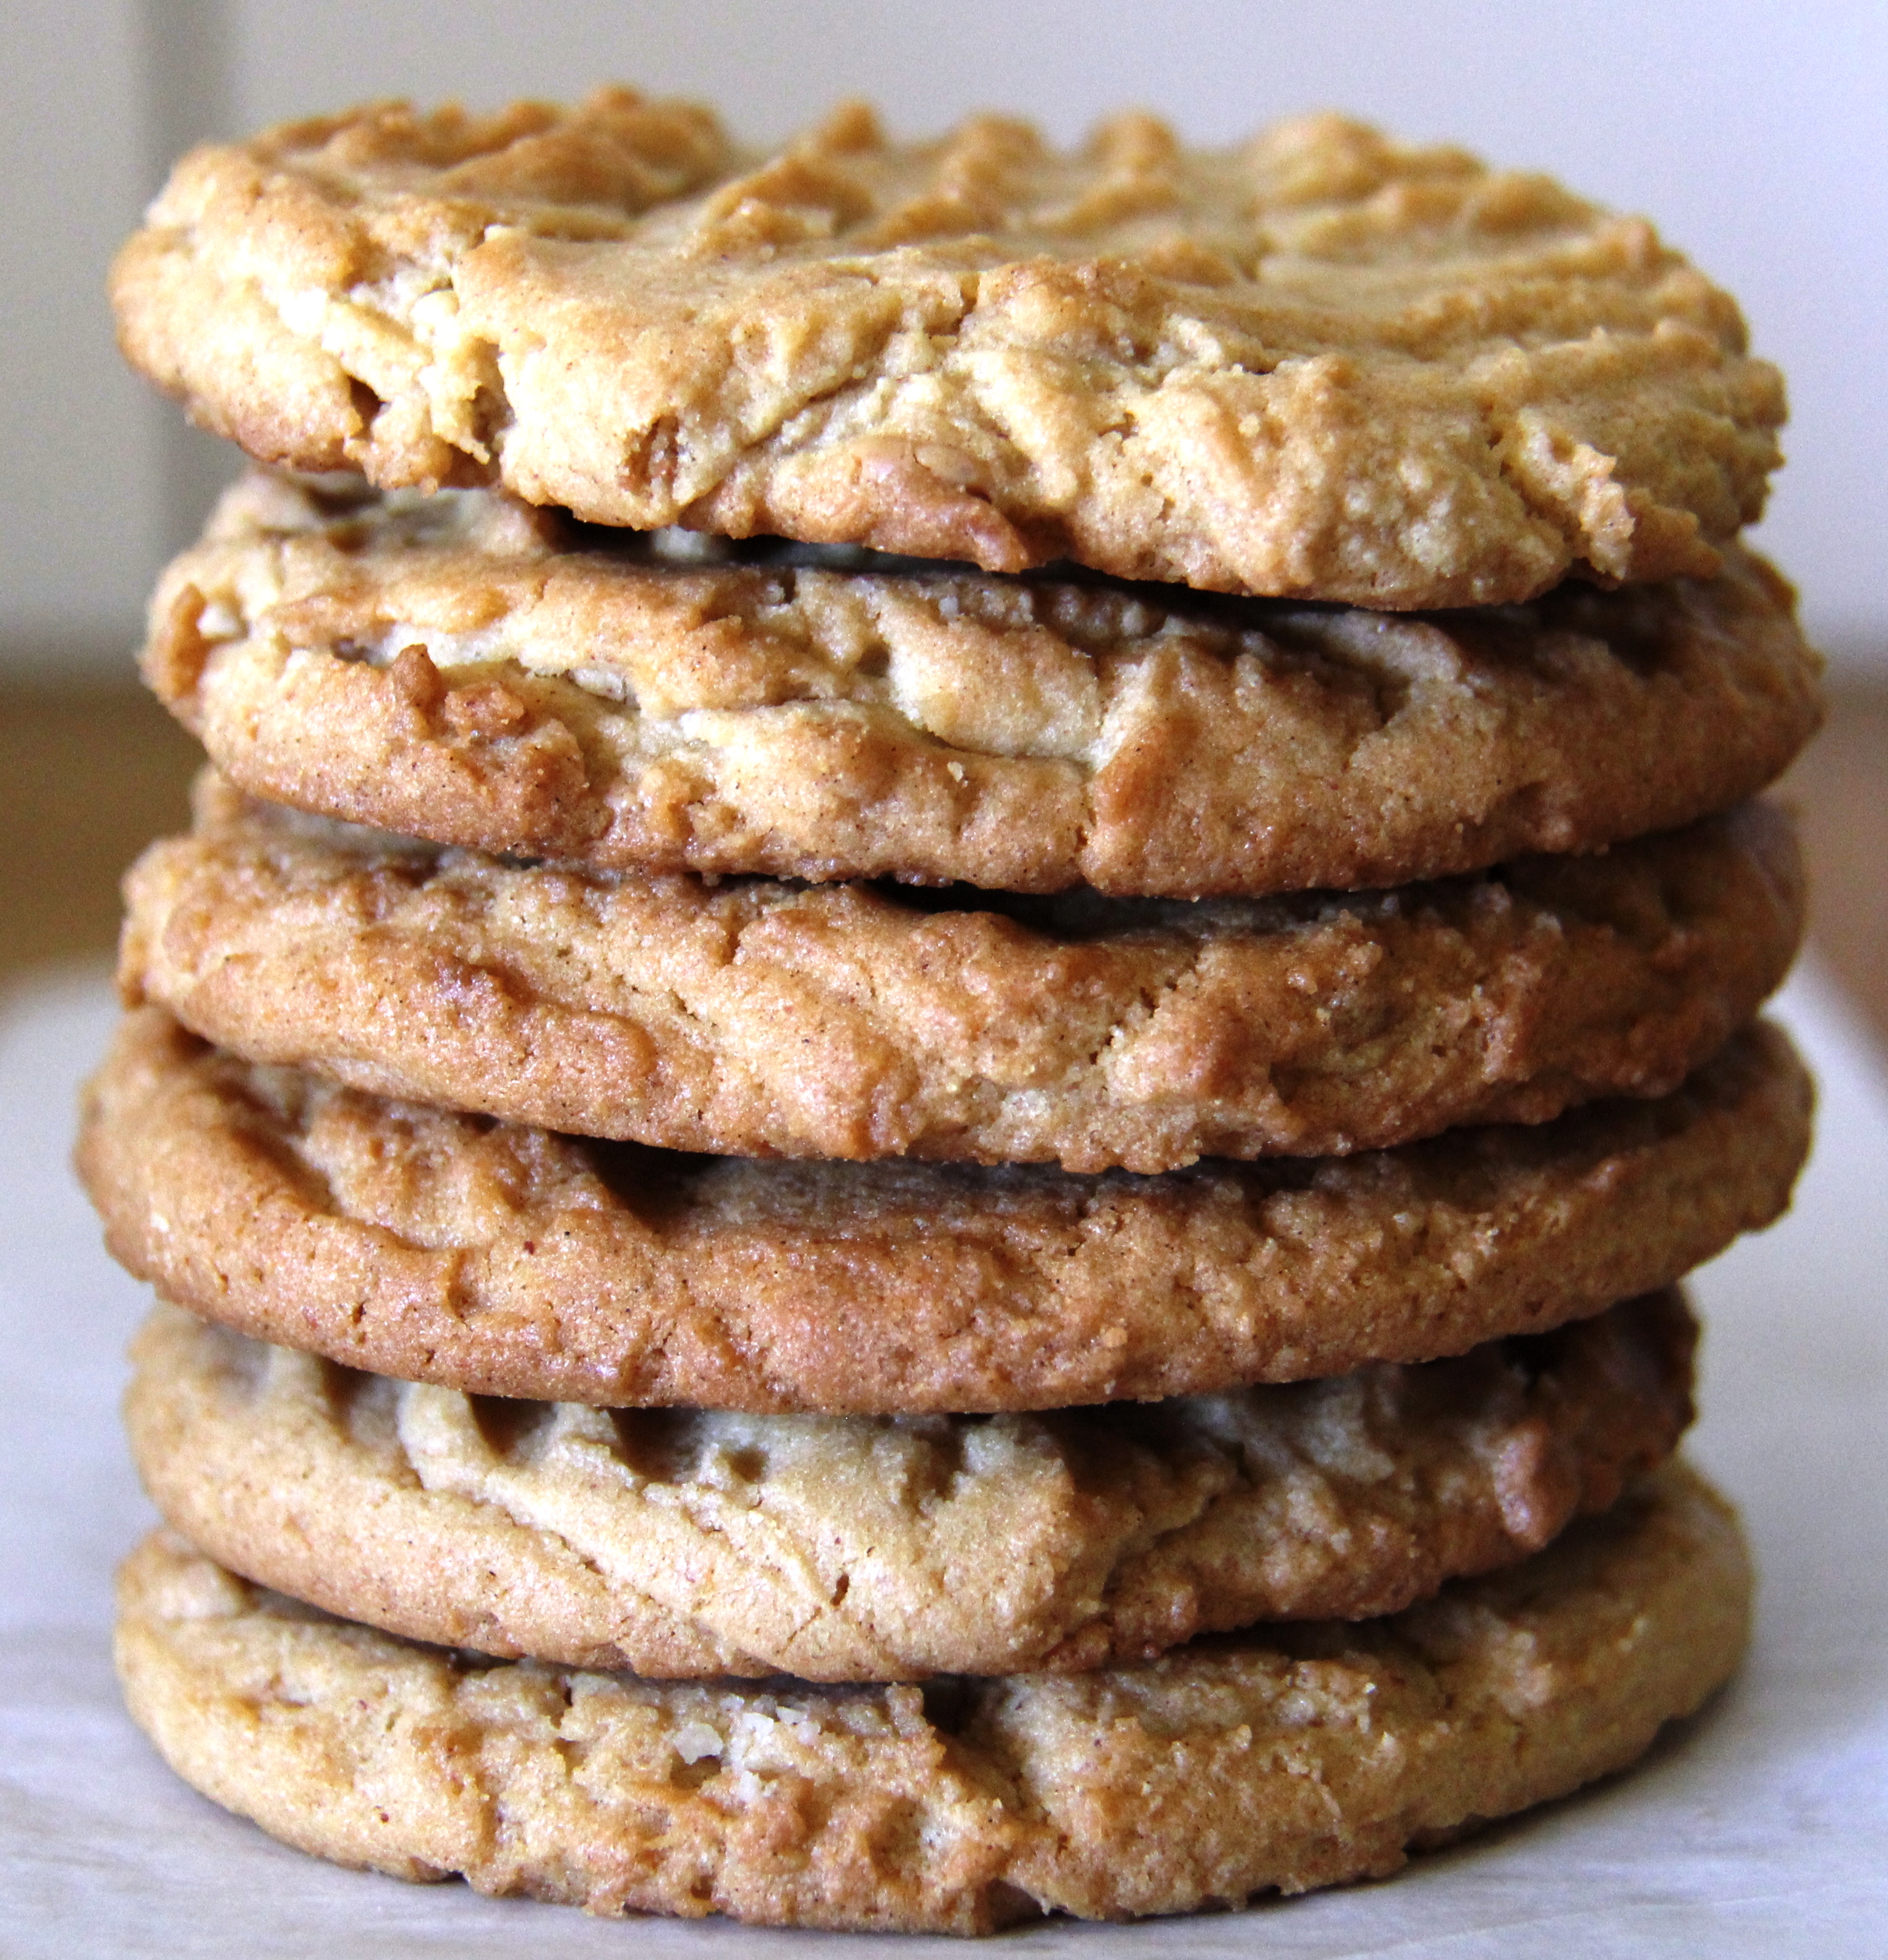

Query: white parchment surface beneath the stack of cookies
[0,968,1888,1960]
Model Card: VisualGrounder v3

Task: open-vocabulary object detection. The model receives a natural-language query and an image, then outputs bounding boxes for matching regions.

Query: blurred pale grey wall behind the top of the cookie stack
[0,0,1888,678]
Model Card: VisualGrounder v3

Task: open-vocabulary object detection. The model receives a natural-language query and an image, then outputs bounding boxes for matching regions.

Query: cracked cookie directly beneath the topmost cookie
[143,474,1819,896]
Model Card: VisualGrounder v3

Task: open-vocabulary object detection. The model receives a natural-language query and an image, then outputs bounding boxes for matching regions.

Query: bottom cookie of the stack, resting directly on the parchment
[117,1466,1751,1933]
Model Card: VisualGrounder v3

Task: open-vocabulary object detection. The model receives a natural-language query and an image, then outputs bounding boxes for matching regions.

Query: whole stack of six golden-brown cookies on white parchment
[80,90,1818,1930]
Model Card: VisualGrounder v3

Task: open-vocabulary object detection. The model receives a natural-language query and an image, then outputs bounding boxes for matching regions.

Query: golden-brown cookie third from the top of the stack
[119,780,1801,1172]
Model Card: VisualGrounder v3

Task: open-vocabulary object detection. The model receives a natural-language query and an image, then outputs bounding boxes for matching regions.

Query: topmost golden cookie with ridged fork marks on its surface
[112,88,1784,608]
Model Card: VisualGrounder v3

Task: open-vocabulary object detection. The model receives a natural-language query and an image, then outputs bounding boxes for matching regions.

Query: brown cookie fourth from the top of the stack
[79,1008,1809,1415]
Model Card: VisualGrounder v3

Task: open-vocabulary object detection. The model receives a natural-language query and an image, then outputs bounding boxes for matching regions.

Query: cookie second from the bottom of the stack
[125,1292,1698,1682]
